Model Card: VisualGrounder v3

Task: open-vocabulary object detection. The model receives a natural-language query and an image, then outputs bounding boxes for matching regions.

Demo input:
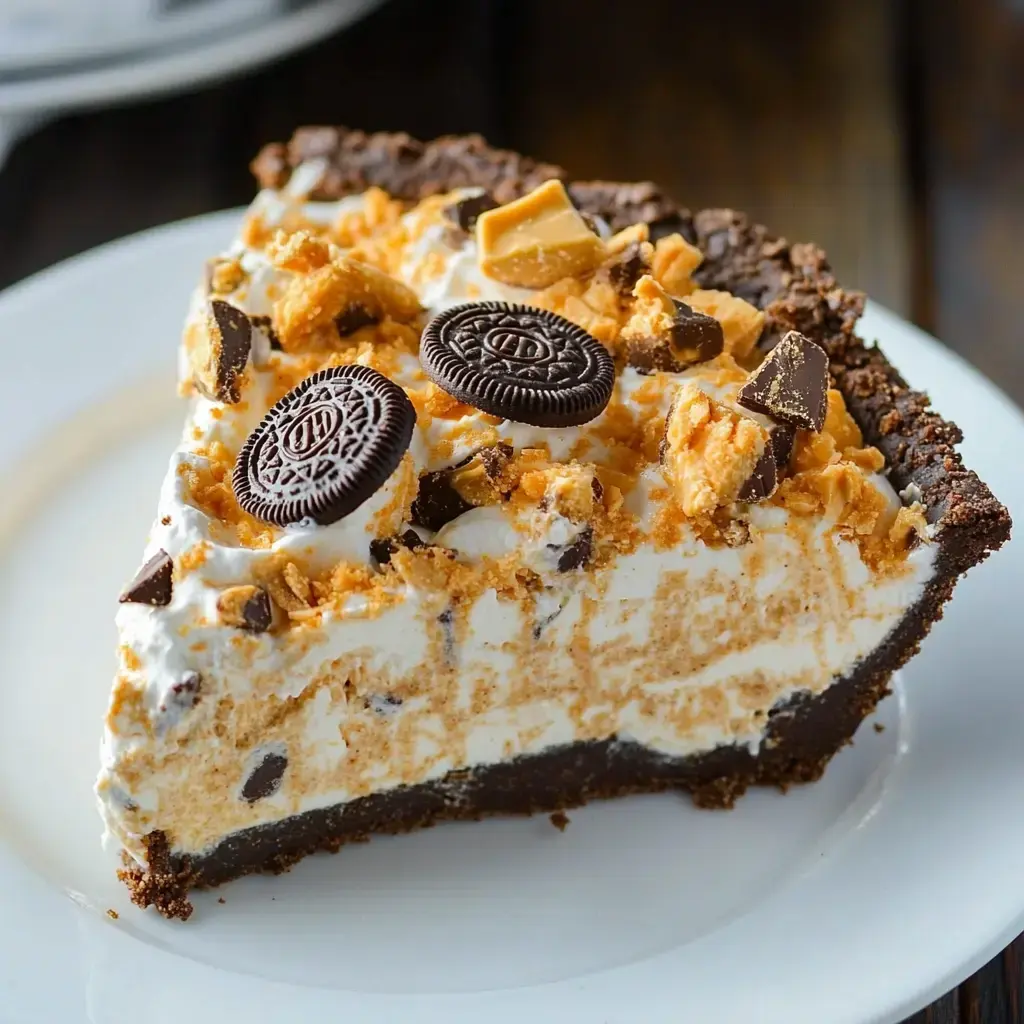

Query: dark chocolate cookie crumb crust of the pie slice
[122,128,1011,919]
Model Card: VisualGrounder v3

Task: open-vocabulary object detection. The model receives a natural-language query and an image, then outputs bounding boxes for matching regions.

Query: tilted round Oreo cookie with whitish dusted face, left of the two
[232,365,416,526]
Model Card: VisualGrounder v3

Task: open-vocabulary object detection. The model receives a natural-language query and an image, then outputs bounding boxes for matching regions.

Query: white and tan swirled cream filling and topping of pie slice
[97,165,935,861]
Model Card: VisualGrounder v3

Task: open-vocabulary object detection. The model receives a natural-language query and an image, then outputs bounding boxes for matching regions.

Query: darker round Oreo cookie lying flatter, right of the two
[420,302,615,427]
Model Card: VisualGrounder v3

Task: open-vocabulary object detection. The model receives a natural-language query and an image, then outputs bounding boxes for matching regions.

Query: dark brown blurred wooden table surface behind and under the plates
[0,0,1024,1011]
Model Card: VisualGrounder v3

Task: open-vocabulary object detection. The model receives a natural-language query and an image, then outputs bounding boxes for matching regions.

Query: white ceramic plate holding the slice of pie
[0,214,1024,1024]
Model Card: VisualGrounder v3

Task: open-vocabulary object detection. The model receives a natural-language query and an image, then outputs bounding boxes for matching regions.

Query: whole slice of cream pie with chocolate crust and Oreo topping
[97,128,1010,919]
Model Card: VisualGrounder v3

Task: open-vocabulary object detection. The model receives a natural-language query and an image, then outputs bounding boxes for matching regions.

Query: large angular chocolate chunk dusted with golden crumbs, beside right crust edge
[737,331,828,430]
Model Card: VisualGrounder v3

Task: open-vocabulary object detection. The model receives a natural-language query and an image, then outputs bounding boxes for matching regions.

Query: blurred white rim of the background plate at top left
[0,0,382,115]
